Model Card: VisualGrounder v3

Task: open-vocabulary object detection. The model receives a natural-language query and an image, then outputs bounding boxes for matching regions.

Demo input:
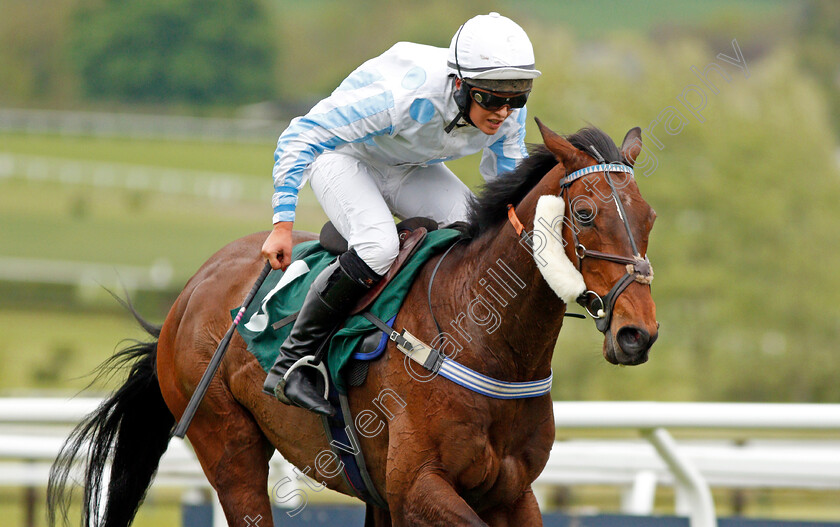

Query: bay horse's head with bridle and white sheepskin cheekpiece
[534,120,659,365]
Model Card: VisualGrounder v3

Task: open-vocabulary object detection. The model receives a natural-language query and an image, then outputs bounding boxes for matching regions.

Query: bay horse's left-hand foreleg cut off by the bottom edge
[388,472,487,527]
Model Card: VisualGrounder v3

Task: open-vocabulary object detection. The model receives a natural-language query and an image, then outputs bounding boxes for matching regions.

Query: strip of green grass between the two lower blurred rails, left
[0,181,270,278]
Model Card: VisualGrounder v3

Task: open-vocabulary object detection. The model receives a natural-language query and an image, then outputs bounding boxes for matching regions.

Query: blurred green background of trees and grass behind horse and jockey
[0,0,840,525]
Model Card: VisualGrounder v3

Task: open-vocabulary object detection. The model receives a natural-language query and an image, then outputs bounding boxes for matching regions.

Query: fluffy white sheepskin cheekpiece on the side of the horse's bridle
[531,195,586,304]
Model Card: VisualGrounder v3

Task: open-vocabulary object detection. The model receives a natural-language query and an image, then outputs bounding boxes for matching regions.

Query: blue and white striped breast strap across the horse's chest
[364,312,554,399]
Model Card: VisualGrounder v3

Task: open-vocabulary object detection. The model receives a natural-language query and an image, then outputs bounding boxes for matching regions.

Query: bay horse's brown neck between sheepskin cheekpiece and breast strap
[452,229,565,381]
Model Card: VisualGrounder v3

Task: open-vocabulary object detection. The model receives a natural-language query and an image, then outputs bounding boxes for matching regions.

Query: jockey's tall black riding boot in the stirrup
[263,250,380,415]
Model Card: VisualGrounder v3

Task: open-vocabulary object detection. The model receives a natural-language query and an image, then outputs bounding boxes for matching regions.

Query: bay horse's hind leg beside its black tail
[188,408,274,527]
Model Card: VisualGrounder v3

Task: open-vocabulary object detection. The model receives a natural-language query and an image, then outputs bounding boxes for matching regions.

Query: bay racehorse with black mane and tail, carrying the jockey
[48,120,658,527]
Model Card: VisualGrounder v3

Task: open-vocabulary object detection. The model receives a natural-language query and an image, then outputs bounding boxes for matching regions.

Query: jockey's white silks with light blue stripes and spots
[272,42,527,223]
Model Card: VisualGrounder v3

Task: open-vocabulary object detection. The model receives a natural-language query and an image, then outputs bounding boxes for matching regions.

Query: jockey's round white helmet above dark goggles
[447,13,542,80]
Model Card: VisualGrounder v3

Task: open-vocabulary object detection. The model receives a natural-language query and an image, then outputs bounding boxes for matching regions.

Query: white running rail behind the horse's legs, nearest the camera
[0,398,840,527]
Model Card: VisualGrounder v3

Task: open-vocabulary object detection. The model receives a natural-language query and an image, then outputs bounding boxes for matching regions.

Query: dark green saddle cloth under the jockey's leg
[231,229,462,393]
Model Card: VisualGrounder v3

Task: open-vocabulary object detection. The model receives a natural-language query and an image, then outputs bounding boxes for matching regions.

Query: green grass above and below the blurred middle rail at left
[0,131,332,282]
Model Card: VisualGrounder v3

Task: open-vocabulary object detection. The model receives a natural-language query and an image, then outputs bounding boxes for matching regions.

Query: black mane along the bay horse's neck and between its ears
[453,127,623,238]
